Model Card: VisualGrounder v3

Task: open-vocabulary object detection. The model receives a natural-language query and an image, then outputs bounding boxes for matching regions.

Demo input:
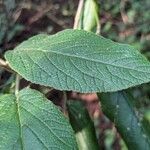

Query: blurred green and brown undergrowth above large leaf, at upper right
[100,0,150,52]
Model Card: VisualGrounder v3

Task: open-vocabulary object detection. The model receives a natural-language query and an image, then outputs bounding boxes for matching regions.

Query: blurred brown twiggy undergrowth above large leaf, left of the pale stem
[0,0,77,54]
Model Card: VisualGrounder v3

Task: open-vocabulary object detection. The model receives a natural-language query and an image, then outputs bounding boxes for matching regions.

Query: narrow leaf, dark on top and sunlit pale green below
[68,101,99,150]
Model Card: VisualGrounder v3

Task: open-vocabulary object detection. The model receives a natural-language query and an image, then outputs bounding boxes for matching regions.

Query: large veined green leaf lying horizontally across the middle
[5,29,150,93]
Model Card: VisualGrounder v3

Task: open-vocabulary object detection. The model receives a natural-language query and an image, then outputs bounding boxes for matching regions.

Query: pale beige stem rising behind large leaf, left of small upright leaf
[73,0,84,29]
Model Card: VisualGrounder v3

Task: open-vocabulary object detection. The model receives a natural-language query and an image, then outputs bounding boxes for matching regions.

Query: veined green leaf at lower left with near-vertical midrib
[0,89,77,150]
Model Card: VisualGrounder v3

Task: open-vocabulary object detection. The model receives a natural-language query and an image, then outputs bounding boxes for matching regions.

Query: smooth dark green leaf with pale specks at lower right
[98,91,150,150]
